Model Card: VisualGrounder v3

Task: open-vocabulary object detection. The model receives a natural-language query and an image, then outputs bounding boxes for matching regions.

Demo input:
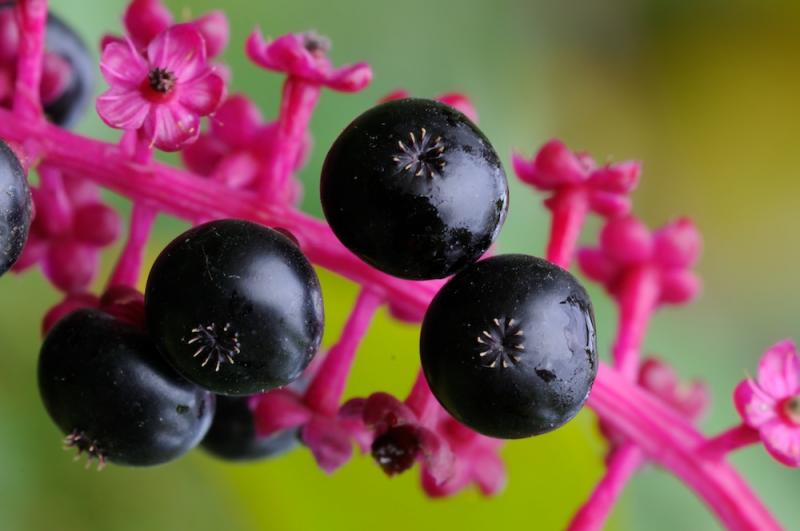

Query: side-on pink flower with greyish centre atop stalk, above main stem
[246,30,372,92]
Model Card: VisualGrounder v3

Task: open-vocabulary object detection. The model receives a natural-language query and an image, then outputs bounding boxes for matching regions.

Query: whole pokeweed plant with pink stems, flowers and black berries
[0,0,800,530]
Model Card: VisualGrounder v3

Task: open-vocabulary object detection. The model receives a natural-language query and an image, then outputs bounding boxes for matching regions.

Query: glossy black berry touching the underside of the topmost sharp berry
[420,255,597,439]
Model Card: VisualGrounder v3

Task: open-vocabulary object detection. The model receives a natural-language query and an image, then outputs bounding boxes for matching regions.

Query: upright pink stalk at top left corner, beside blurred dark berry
[13,0,47,119]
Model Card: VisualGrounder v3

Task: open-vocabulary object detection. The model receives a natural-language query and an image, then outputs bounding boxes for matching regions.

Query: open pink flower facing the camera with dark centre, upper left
[97,24,225,151]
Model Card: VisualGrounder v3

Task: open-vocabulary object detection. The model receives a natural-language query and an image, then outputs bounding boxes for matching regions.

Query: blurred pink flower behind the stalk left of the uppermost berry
[181,94,311,200]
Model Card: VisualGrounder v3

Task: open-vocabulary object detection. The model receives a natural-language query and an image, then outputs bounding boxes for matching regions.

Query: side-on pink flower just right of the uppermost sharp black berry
[512,140,641,217]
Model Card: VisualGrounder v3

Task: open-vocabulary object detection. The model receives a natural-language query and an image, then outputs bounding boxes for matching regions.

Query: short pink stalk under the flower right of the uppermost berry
[547,187,589,269]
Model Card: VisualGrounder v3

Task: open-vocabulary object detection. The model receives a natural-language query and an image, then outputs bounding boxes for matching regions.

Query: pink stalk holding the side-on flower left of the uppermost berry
[259,76,321,202]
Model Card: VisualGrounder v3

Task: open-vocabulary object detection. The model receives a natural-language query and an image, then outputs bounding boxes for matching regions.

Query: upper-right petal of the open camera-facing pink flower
[147,24,207,83]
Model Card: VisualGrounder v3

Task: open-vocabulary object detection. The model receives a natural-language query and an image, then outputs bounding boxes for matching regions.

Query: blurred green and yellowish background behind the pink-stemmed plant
[0,0,800,531]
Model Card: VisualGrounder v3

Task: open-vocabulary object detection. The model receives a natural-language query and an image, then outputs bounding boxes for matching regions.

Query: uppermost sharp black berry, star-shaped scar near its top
[320,99,508,280]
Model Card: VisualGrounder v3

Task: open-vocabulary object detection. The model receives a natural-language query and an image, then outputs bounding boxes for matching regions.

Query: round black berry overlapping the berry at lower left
[145,220,323,395]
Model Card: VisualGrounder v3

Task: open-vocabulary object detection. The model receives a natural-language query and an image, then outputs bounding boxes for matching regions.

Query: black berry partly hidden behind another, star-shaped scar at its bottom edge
[39,309,214,466]
